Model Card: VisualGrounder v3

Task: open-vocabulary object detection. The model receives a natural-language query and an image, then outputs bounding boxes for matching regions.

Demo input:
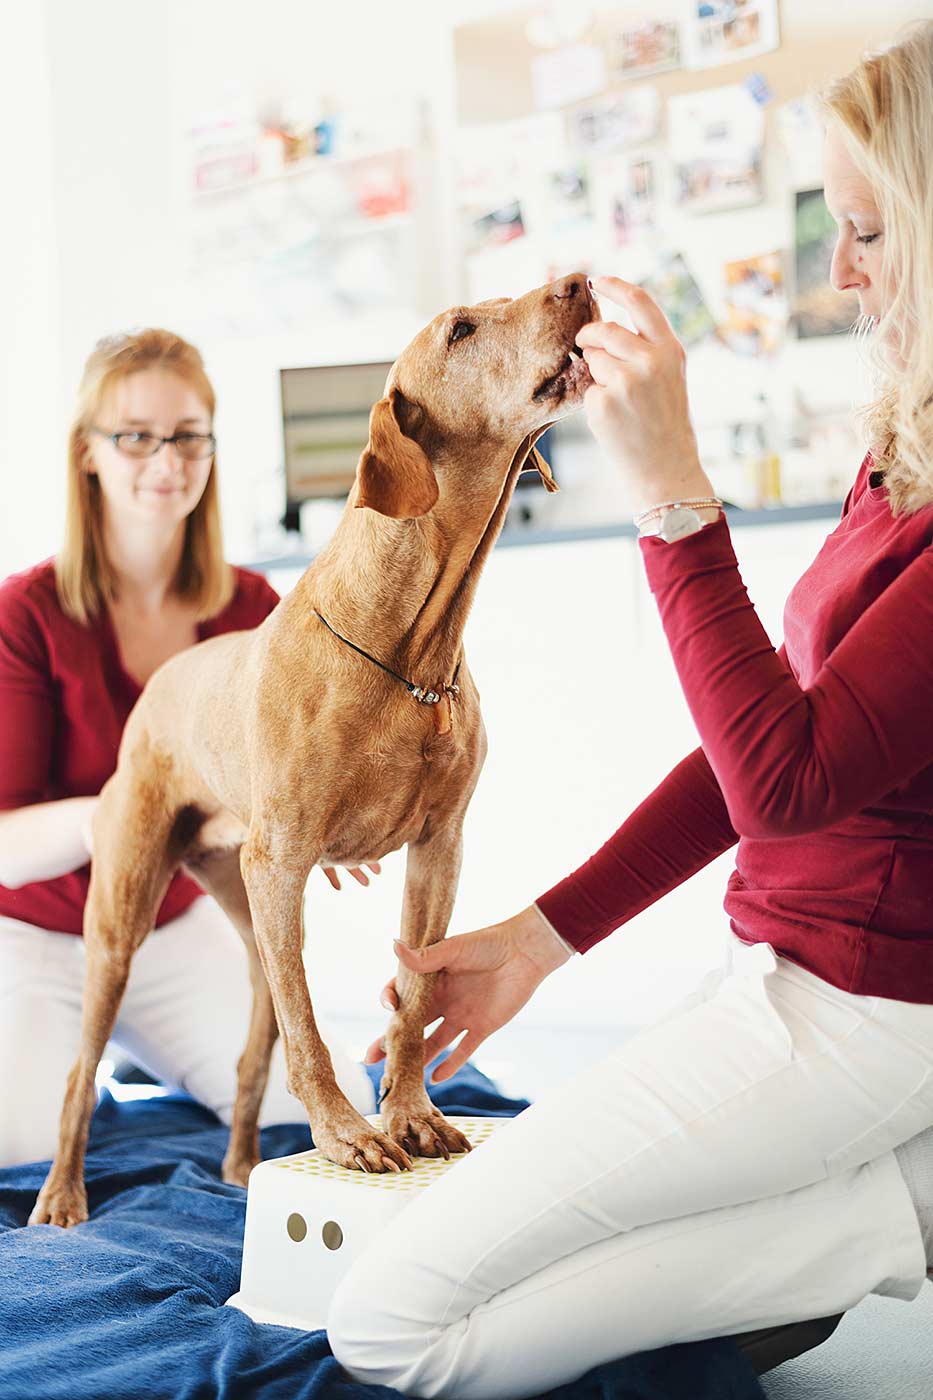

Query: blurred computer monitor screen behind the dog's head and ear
[280,361,392,512]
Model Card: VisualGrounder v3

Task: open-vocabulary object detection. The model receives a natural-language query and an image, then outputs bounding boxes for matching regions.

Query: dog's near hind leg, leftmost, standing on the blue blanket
[29,773,182,1226]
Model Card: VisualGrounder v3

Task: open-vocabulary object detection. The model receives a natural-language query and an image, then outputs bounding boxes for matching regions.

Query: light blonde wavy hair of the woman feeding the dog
[818,20,933,515]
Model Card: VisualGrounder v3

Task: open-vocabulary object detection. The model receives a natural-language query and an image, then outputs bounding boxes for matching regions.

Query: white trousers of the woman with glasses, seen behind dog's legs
[0,896,375,1166]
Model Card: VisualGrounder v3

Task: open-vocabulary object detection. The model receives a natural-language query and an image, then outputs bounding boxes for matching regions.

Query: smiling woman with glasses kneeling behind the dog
[0,330,374,1166]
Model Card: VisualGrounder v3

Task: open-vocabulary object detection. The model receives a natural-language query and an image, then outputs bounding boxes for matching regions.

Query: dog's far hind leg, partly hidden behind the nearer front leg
[185,847,279,1186]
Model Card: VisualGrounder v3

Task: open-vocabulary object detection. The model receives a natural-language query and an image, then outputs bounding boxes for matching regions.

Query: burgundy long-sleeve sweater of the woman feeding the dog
[538,455,933,1002]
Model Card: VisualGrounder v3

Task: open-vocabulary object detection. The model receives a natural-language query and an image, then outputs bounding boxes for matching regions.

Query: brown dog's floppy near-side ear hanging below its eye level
[354,386,438,519]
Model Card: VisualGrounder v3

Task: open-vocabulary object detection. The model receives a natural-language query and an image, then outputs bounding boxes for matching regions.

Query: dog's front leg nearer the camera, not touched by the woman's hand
[240,832,412,1172]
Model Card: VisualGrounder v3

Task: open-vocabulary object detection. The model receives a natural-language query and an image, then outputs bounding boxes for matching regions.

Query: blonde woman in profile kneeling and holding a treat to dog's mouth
[328,24,933,1400]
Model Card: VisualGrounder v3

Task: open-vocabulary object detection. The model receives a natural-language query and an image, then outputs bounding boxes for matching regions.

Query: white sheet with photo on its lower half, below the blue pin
[667,83,765,214]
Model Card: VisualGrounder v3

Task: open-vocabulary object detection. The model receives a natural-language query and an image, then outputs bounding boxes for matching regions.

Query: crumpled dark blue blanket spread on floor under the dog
[0,1065,763,1400]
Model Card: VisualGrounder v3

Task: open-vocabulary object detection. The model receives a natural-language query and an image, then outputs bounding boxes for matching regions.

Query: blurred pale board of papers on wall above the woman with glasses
[185,92,419,339]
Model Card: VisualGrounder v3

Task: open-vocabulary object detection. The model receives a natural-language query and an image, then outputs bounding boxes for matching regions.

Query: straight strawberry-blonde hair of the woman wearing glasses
[55,329,235,624]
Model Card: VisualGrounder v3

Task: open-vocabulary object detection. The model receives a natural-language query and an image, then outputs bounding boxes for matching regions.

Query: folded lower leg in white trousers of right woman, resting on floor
[328,1152,926,1400]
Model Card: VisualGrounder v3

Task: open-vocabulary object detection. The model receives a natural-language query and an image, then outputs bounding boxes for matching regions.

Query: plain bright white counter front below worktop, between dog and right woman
[288,515,832,1033]
